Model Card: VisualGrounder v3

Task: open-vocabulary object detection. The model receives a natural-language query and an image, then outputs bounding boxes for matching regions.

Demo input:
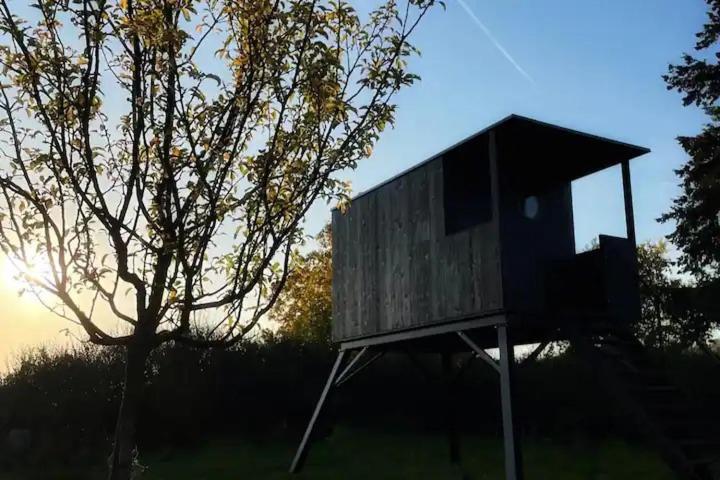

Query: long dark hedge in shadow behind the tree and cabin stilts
[0,337,720,467]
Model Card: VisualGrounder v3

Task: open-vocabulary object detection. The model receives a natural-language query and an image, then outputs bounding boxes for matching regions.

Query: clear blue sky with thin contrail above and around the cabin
[308,0,706,253]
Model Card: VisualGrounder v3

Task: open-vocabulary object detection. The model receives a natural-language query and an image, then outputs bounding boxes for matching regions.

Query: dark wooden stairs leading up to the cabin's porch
[571,323,720,480]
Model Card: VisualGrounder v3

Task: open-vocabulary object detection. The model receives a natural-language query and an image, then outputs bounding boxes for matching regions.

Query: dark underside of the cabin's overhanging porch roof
[492,115,649,191]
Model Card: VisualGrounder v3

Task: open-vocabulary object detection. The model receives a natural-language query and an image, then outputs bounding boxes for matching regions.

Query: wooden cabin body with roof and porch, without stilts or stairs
[332,115,648,344]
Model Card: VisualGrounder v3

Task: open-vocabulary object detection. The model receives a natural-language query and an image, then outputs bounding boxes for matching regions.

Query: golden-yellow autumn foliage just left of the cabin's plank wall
[270,225,332,344]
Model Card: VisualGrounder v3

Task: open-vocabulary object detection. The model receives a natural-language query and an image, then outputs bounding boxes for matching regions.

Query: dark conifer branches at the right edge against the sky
[660,0,720,281]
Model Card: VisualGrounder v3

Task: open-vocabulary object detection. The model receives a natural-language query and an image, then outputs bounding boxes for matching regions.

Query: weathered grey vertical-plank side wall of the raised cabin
[332,139,503,341]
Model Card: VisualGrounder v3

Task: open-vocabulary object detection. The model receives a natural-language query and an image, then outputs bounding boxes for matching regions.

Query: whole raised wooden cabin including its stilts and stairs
[291,115,718,480]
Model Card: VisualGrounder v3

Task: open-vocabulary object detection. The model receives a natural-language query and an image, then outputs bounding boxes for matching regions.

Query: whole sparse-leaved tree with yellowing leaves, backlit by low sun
[0,0,437,480]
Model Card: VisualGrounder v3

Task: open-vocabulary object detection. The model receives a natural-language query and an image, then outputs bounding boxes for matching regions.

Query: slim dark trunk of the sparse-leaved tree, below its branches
[108,345,150,480]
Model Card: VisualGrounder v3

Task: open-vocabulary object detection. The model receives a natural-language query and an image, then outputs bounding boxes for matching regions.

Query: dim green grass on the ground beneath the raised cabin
[0,429,672,480]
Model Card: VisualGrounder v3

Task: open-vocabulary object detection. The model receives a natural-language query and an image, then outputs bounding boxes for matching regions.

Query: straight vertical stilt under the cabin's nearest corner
[497,324,523,480]
